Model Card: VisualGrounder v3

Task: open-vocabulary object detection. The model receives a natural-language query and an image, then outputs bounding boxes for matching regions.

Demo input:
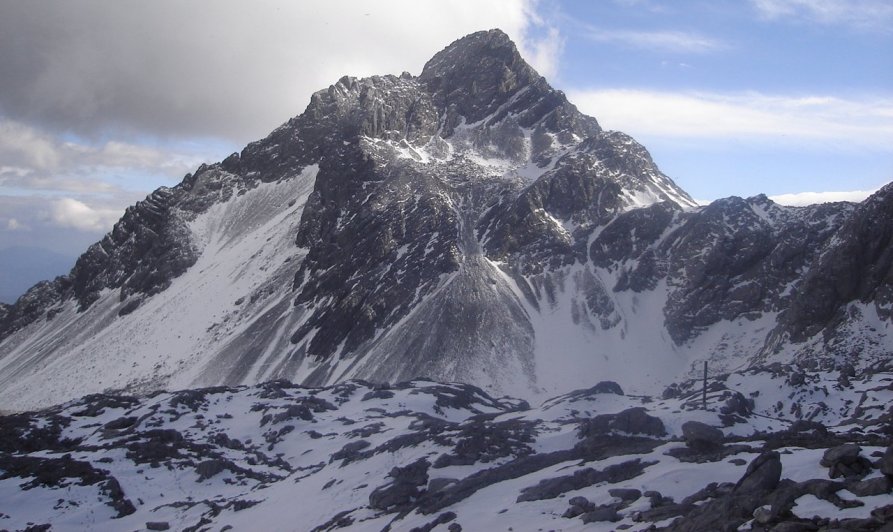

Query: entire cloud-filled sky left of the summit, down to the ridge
[0,0,560,253]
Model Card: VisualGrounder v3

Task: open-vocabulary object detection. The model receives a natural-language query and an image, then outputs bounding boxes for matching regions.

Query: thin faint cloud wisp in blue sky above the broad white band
[585,26,728,54]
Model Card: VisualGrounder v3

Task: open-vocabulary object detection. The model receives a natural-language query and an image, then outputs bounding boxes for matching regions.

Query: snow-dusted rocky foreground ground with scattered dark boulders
[0,364,893,532]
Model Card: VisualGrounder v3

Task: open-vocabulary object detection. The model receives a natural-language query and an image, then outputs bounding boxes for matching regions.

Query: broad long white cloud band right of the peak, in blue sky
[568,89,893,151]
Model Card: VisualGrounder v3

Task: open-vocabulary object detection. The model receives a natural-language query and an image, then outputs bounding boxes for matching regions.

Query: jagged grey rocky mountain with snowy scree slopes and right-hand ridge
[0,30,893,410]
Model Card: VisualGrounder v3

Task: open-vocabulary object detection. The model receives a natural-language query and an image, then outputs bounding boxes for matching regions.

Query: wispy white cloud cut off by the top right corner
[751,0,893,32]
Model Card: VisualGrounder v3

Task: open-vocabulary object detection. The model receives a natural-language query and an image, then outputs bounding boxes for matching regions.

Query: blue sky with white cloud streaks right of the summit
[541,0,893,200]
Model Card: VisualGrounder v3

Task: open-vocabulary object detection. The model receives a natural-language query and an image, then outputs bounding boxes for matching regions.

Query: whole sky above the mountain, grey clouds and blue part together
[0,0,893,257]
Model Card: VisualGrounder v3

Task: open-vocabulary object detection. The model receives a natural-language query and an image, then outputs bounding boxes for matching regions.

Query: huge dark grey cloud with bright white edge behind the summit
[0,0,561,143]
